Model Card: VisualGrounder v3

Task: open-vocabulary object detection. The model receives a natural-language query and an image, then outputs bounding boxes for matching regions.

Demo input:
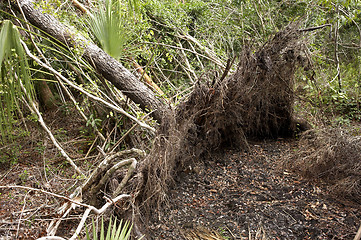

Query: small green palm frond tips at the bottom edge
[86,218,132,240]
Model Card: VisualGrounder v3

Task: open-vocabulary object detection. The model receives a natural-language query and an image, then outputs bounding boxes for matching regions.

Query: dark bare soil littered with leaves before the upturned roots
[150,140,361,239]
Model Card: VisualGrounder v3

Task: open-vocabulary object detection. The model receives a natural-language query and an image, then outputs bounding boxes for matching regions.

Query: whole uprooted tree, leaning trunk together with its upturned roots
[10,0,310,239]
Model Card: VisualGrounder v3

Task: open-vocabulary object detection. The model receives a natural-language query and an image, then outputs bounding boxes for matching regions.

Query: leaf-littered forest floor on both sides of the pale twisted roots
[0,116,361,240]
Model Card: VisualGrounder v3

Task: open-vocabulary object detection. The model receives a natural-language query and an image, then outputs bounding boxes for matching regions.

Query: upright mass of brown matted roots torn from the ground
[138,24,304,214]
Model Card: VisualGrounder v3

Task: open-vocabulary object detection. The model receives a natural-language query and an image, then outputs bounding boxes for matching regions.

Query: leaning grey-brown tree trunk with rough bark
[17,0,170,122]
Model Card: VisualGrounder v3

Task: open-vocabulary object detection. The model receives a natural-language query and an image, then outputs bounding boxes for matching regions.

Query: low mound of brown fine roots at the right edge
[285,128,361,202]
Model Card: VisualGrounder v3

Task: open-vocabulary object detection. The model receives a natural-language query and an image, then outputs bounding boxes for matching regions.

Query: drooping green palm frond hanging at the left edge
[0,20,34,142]
